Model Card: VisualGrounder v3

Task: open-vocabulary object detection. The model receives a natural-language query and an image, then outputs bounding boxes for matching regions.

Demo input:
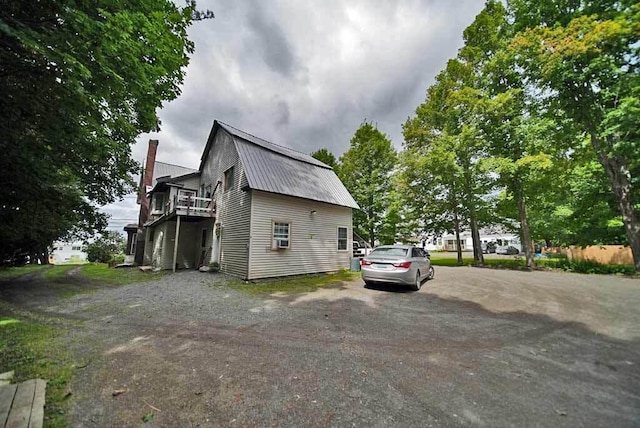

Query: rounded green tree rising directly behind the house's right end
[340,122,396,246]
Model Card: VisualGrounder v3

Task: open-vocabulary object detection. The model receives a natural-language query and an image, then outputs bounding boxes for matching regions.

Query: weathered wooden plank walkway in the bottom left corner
[0,379,47,428]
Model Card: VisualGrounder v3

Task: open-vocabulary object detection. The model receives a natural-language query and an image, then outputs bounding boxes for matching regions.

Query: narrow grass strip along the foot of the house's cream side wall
[229,270,360,294]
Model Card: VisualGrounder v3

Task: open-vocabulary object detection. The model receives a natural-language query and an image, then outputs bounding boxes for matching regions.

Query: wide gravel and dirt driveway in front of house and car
[1,267,640,427]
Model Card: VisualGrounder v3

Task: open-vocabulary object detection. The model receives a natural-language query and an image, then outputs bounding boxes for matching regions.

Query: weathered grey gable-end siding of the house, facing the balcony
[200,129,251,278]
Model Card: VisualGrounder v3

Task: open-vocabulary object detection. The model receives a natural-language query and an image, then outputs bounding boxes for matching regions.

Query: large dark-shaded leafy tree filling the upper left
[0,0,212,260]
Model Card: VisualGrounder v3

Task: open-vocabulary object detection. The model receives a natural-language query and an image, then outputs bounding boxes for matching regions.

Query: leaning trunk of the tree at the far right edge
[591,137,640,272]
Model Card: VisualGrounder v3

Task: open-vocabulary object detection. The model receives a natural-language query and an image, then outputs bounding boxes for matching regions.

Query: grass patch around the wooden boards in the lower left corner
[0,305,73,427]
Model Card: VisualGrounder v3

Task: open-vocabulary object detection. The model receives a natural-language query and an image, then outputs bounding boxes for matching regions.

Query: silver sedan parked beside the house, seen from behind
[360,245,435,290]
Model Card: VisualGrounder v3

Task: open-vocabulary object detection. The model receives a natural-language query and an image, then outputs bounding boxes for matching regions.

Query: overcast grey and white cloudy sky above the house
[104,0,484,230]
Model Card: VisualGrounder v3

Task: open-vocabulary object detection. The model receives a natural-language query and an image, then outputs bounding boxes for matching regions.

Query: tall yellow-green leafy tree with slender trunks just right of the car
[404,50,491,263]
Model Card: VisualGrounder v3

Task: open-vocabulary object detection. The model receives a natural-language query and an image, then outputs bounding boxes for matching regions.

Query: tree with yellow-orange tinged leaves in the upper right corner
[509,0,640,270]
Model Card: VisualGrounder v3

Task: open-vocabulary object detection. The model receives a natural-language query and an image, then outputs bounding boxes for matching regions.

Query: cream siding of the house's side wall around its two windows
[248,191,353,279]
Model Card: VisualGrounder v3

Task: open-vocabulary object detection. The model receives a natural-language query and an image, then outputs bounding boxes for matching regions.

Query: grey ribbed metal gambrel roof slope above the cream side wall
[217,122,360,209]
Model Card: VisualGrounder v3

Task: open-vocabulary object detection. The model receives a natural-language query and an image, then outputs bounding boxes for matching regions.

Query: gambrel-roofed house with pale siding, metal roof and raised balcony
[144,121,358,279]
